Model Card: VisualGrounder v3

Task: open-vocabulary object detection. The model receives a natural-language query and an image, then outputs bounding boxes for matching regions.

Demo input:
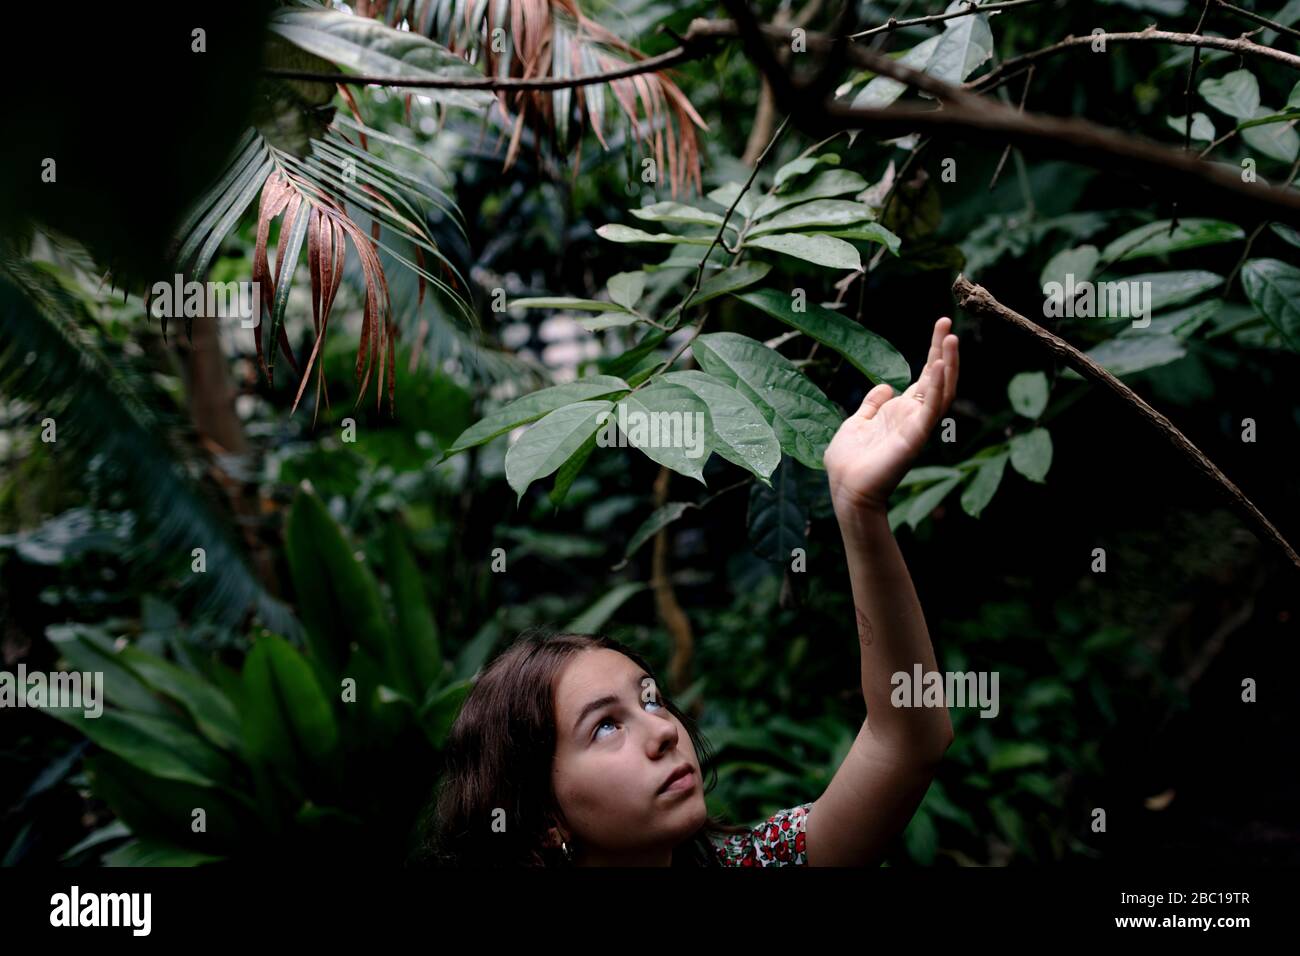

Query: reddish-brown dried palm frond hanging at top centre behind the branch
[390,0,709,198]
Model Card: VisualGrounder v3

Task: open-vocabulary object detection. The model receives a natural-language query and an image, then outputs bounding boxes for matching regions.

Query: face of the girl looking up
[551,648,707,866]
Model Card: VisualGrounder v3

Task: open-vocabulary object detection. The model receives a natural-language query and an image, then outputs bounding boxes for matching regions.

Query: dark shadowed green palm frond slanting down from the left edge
[0,252,300,637]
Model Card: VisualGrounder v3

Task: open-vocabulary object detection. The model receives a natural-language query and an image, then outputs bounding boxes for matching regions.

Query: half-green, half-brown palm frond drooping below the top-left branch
[164,116,477,411]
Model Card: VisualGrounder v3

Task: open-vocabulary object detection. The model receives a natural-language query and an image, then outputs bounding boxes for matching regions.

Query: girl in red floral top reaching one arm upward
[437,317,958,866]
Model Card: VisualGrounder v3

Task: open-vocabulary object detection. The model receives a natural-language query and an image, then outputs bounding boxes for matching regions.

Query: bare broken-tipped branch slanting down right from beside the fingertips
[953,276,1300,568]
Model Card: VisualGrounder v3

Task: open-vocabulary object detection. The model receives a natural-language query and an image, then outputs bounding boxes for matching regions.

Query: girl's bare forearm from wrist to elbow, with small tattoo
[837,509,953,760]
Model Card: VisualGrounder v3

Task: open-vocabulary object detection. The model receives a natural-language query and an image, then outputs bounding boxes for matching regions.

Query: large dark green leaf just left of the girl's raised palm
[692,332,844,470]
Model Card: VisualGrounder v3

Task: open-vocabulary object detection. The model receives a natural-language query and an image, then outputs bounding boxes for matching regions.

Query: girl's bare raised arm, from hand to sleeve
[807,317,958,866]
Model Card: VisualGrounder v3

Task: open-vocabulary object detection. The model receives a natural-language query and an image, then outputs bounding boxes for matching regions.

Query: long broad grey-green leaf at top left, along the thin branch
[269,9,494,109]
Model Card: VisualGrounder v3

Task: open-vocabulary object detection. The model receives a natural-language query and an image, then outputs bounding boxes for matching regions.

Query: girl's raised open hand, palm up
[822,316,959,515]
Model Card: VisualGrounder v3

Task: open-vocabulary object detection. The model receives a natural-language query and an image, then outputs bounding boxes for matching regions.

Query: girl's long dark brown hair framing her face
[425,628,746,866]
